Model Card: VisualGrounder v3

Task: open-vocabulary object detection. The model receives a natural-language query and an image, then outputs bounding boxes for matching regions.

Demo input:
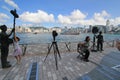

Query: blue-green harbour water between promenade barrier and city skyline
[17,33,120,44]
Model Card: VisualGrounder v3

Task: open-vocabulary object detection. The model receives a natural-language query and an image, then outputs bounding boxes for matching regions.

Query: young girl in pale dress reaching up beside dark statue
[13,33,22,64]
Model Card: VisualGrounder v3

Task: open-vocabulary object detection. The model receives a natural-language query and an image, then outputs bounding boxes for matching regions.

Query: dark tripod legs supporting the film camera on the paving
[44,41,61,70]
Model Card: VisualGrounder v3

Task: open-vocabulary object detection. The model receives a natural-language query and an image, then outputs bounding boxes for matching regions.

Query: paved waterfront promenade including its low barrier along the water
[0,43,120,80]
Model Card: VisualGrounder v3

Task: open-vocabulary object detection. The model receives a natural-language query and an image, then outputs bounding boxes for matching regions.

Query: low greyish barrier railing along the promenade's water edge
[7,40,117,56]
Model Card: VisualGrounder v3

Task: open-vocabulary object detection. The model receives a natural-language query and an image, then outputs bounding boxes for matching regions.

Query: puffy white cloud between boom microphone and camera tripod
[20,10,54,23]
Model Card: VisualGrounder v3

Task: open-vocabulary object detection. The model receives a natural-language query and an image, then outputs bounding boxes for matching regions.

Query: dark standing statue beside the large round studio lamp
[96,31,104,51]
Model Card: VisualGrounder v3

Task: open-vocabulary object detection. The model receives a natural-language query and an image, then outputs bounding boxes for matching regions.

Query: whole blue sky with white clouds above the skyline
[0,0,120,27]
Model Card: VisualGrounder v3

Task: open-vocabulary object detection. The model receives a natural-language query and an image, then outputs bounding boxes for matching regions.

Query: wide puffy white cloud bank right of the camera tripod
[58,9,110,25]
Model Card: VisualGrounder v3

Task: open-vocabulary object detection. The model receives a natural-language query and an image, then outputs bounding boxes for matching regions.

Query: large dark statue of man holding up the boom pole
[0,25,15,68]
